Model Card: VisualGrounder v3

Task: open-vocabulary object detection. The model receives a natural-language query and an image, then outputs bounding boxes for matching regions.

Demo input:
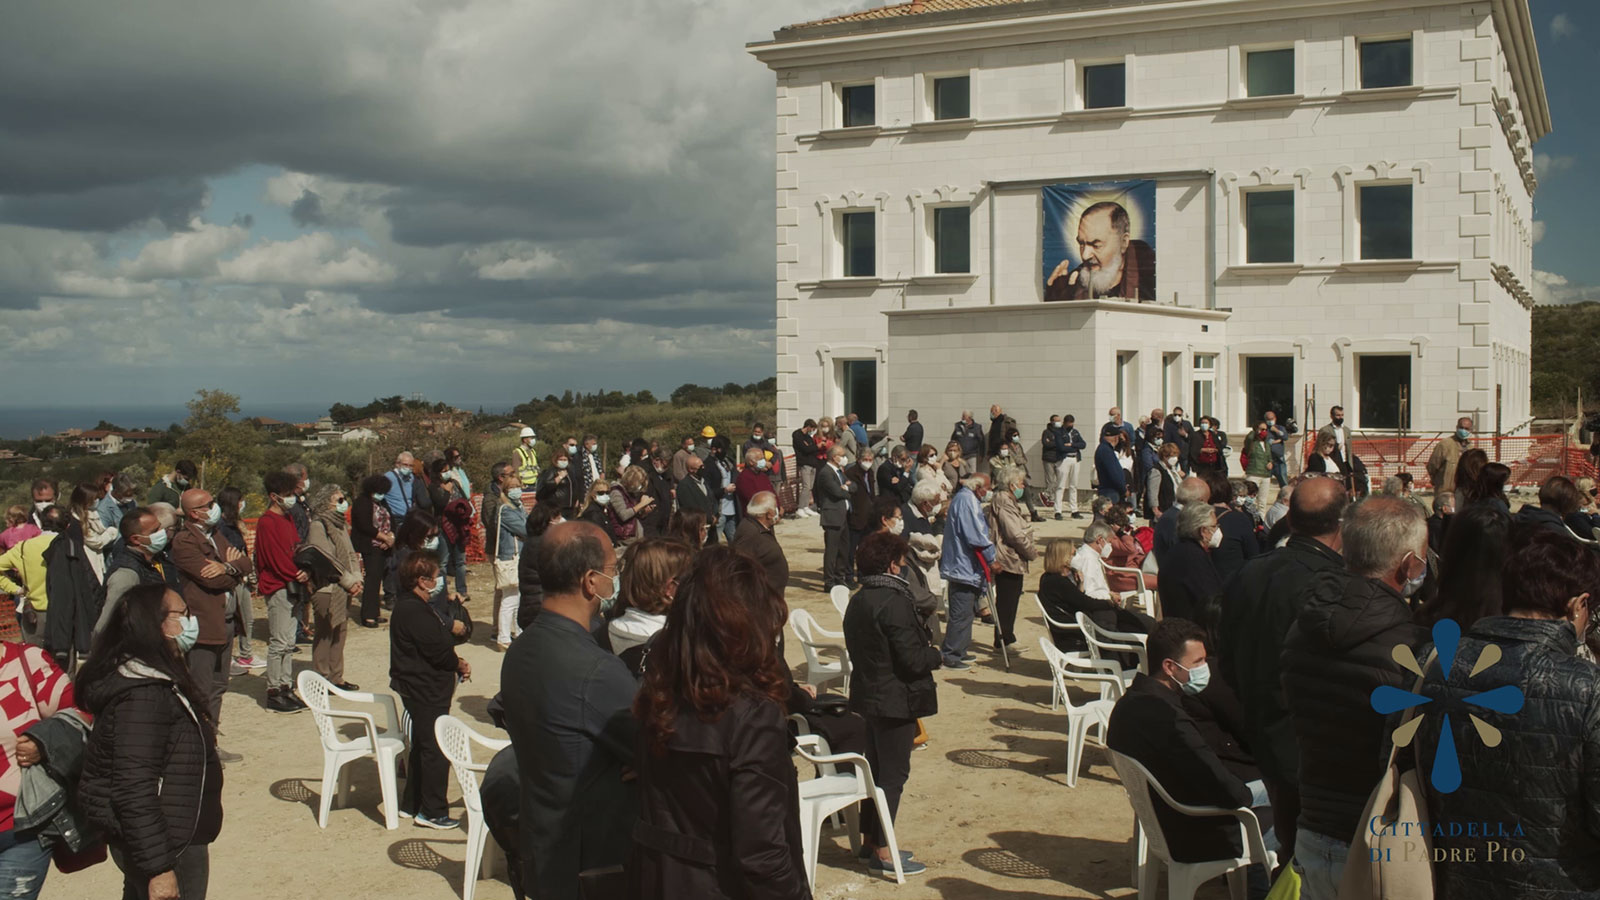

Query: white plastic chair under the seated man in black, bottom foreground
[1109,751,1278,900]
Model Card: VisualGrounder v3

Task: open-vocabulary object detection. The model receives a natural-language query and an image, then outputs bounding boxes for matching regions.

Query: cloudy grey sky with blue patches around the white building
[0,0,1600,408]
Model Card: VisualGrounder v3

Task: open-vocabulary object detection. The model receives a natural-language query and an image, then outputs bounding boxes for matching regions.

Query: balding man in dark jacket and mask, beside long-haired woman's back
[501,522,638,900]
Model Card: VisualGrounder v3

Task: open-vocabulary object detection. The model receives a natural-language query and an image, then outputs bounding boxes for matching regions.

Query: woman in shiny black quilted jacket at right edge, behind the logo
[1400,528,1600,900]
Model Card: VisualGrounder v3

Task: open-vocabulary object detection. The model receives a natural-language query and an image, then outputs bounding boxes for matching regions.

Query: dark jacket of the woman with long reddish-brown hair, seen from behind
[627,695,811,900]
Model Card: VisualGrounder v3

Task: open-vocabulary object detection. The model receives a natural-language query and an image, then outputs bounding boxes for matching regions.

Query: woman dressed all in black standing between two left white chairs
[389,550,472,831]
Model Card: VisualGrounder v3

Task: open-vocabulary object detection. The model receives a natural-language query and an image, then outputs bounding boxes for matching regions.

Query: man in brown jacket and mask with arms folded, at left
[171,488,253,762]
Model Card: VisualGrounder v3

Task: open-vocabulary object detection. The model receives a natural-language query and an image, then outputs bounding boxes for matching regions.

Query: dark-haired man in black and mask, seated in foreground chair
[1106,618,1273,897]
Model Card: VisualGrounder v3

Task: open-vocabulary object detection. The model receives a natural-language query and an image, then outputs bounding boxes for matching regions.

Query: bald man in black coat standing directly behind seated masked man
[1218,477,1349,852]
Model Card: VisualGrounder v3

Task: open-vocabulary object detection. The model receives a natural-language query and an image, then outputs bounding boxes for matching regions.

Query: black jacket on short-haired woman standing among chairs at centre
[845,575,941,719]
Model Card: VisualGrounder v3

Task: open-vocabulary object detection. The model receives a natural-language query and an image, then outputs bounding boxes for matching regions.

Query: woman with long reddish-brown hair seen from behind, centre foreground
[627,546,811,900]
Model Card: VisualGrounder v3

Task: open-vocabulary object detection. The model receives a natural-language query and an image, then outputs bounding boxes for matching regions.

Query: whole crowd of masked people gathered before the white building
[0,405,1600,900]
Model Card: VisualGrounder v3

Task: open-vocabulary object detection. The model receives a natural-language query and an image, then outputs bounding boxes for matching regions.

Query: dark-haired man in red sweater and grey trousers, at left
[256,470,310,713]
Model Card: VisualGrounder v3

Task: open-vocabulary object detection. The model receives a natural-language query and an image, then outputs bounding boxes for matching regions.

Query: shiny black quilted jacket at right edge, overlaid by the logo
[1402,617,1600,900]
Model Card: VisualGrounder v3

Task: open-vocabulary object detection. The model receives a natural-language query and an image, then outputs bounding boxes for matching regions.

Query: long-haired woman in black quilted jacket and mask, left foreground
[75,585,222,900]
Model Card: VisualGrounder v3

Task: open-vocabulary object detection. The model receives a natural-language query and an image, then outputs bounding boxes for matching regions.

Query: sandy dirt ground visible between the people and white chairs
[43,517,1226,900]
